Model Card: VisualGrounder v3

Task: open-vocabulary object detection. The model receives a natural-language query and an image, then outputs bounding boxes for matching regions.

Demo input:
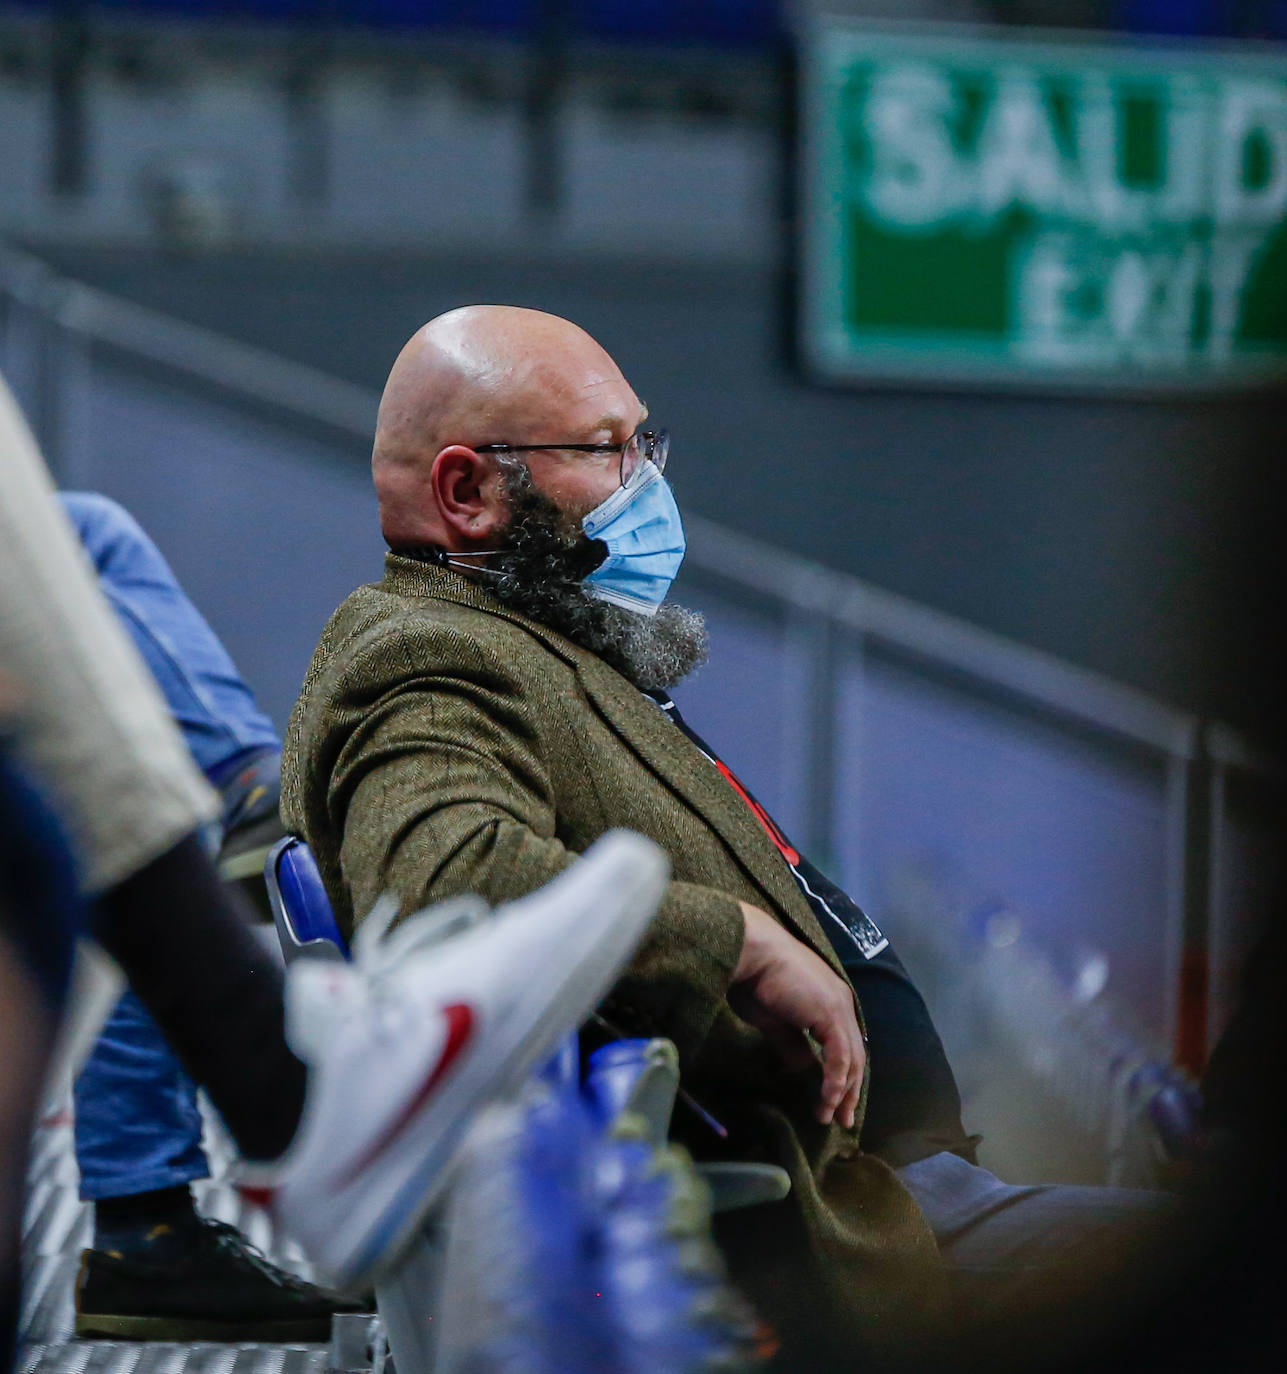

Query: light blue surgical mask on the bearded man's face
[581,462,685,616]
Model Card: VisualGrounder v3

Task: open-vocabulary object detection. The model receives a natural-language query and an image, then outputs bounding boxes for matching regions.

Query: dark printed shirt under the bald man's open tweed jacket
[648,692,978,1167]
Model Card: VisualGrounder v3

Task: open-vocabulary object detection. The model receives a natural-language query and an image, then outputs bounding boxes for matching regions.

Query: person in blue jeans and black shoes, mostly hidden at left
[60,492,356,1341]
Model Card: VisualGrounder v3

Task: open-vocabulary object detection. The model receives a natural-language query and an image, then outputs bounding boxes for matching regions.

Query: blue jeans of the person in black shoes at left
[62,492,280,1200]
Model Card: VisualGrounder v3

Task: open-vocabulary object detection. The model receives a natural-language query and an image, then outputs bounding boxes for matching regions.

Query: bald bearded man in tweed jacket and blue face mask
[283,306,1175,1367]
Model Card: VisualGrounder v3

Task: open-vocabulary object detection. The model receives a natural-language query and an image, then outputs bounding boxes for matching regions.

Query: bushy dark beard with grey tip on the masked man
[488,463,709,691]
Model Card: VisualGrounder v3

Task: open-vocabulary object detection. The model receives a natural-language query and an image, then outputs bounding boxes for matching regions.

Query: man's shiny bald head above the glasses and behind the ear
[371,305,640,548]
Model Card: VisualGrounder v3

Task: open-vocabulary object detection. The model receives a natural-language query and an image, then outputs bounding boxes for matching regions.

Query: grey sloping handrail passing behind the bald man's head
[0,247,1251,760]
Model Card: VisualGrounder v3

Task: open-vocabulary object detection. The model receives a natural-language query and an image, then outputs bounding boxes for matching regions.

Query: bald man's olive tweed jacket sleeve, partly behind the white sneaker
[327,623,743,1055]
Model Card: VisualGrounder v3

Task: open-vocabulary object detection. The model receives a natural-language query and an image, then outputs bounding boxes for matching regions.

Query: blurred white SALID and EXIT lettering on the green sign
[850,62,1287,364]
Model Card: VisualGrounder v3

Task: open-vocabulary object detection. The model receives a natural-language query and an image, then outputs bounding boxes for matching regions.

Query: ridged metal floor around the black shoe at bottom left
[15,1103,327,1374]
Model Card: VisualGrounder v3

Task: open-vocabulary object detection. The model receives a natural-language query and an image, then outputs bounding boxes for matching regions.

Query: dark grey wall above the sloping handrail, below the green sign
[30,240,1287,741]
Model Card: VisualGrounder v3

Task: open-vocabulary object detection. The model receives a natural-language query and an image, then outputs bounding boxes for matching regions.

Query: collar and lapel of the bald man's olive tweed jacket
[385,554,843,974]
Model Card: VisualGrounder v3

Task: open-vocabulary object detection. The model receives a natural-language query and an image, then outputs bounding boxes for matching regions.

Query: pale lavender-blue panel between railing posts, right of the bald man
[836,657,1169,1035]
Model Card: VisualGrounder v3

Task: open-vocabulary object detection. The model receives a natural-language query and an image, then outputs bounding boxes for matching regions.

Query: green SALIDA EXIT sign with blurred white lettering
[801,21,1287,390]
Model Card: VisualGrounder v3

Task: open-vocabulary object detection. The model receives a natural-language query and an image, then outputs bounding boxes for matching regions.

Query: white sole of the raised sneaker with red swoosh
[330,833,670,1293]
